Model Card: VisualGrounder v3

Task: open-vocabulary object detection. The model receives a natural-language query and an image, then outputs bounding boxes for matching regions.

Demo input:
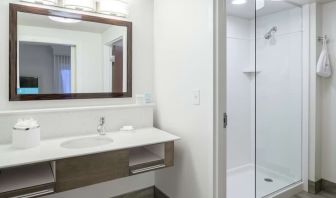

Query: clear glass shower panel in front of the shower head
[255,0,303,198]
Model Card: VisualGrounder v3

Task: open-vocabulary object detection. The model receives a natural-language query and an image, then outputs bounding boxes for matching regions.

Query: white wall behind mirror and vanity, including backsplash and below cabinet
[0,0,154,198]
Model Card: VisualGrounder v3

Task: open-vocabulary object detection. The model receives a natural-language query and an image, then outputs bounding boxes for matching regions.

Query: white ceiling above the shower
[227,0,335,19]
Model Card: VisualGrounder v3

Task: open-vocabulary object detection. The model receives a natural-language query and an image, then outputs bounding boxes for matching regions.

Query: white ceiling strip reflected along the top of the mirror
[18,13,111,33]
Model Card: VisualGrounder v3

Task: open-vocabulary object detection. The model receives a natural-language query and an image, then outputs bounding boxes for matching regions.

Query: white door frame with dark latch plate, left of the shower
[213,0,226,198]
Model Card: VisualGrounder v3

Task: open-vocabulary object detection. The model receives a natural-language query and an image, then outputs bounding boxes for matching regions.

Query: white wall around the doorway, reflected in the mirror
[18,25,104,93]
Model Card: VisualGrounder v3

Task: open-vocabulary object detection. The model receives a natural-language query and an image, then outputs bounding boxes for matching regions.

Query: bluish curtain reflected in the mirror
[54,55,71,94]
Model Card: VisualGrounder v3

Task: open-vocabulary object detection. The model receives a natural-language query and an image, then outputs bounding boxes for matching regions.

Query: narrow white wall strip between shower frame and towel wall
[304,3,322,182]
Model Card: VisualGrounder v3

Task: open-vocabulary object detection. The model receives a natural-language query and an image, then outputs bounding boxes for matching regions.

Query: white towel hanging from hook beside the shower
[317,39,332,78]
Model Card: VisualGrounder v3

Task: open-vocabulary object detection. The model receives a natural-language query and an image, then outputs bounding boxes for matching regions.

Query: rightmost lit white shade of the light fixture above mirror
[97,0,128,17]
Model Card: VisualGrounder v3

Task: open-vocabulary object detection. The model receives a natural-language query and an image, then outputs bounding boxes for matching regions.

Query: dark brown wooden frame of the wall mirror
[9,4,132,101]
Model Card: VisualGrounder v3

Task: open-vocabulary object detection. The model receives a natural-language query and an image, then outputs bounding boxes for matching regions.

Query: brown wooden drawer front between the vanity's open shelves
[56,150,129,192]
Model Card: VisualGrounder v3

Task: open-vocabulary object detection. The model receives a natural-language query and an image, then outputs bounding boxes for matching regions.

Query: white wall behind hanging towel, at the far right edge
[318,2,336,183]
